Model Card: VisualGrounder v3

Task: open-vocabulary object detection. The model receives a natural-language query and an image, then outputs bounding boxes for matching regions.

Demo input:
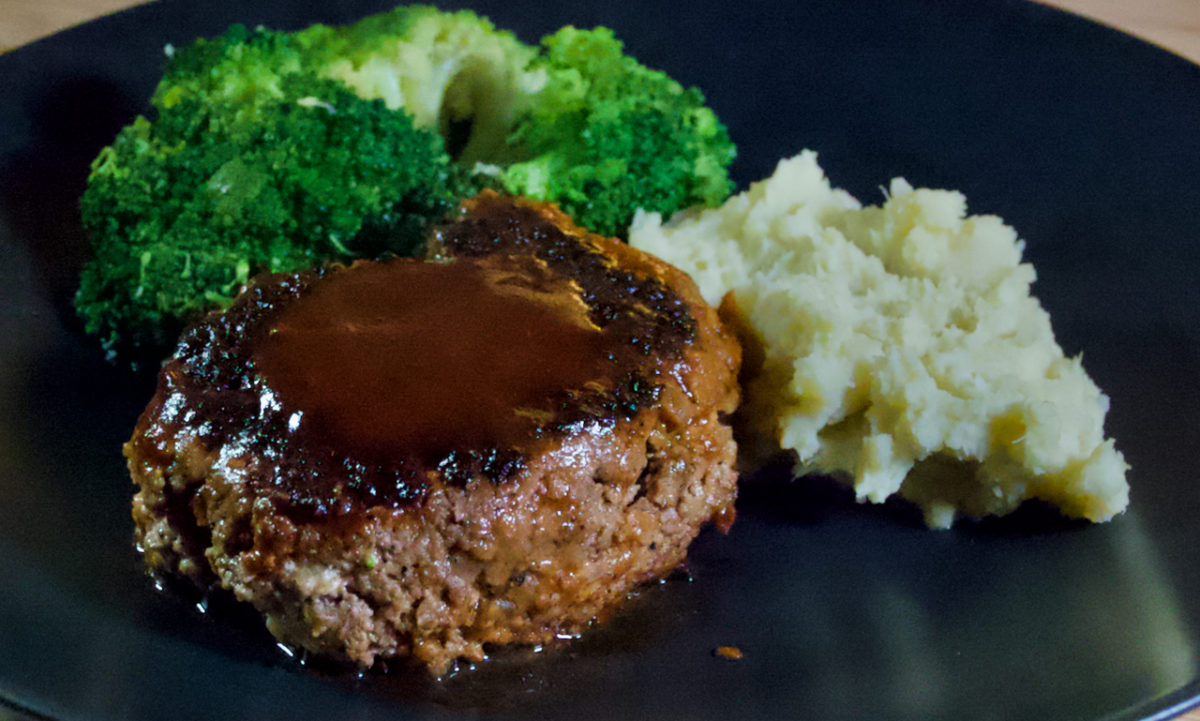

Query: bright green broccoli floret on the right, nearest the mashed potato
[500,28,734,236]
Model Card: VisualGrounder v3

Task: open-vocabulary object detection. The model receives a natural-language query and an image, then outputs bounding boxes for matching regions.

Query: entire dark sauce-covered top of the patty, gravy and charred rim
[138,196,696,519]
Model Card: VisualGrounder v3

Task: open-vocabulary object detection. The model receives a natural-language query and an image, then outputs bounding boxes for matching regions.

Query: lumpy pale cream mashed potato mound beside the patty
[629,151,1129,528]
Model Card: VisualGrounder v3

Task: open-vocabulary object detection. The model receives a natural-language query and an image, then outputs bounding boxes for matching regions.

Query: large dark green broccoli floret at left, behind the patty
[76,73,469,359]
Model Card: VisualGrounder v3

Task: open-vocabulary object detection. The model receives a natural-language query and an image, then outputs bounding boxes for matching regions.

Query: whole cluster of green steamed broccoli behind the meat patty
[77,6,733,352]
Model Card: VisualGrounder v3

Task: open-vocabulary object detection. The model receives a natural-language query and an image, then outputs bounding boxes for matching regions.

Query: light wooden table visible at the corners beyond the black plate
[0,0,1200,721]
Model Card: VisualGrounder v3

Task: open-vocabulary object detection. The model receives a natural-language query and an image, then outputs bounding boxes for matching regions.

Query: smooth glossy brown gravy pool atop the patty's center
[254,256,609,464]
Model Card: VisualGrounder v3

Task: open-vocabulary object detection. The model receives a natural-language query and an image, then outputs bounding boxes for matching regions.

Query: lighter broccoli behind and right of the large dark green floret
[151,6,734,236]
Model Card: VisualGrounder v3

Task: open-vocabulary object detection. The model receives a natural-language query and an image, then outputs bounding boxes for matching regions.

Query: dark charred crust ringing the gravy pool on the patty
[138,194,696,519]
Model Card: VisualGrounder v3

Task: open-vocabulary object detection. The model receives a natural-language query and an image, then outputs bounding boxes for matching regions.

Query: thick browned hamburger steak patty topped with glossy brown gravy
[125,193,739,673]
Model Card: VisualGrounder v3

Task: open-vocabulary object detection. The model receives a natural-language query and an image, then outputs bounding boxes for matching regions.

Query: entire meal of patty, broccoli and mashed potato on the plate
[76,6,1128,674]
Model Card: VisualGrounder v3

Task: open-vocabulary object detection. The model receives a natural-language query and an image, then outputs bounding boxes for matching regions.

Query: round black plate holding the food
[0,0,1200,720]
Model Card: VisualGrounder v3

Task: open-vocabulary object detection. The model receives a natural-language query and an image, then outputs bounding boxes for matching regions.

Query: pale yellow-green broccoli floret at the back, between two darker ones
[151,5,536,164]
